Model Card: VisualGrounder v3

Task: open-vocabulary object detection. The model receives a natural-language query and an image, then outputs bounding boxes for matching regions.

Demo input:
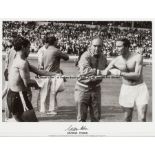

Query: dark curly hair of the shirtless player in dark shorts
[13,36,30,51]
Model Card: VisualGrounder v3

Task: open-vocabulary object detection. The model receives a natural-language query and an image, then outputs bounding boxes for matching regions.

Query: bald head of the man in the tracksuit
[91,37,103,56]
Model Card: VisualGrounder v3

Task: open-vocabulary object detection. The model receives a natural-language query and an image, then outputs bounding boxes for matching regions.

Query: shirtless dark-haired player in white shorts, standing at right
[102,38,149,122]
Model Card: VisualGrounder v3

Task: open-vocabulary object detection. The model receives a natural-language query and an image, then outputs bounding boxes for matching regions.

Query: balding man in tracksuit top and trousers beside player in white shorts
[74,37,107,122]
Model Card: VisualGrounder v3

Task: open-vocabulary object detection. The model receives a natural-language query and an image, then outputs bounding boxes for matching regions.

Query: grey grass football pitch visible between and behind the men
[2,59,152,122]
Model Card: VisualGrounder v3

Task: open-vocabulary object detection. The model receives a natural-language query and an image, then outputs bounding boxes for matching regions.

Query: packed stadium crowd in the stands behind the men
[2,21,152,58]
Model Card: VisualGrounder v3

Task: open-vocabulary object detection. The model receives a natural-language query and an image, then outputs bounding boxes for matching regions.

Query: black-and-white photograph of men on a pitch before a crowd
[2,20,153,124]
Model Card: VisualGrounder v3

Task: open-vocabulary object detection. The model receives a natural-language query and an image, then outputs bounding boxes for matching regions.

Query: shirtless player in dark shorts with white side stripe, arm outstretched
[7,37,55,122]
